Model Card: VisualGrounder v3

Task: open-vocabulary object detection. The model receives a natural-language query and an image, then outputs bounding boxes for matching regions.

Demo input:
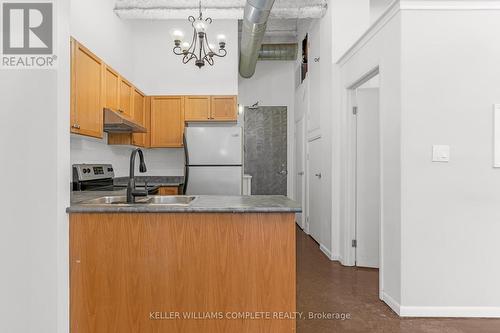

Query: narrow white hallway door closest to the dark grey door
[295,117,306,229]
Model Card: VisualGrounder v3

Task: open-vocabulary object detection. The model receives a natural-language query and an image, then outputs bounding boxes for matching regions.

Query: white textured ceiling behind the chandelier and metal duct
[115,0,328,43]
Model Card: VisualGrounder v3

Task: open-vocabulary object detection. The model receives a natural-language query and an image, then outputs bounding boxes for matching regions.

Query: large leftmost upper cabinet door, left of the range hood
[71,39,103,138]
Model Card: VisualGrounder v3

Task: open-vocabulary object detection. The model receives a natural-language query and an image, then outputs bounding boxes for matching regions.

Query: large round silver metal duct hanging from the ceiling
[240,0,274,78]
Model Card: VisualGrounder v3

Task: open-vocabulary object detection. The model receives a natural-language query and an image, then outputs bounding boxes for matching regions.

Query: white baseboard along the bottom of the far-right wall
[400,306,500,318]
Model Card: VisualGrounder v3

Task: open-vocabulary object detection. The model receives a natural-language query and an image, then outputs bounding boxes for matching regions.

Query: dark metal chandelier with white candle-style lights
[171,1,227,69]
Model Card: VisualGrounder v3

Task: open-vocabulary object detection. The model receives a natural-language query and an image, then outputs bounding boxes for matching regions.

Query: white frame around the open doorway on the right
[343,65,384,295]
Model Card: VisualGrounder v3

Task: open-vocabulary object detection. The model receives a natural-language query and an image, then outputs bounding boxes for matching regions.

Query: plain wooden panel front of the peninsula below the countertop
[70,213,296,333]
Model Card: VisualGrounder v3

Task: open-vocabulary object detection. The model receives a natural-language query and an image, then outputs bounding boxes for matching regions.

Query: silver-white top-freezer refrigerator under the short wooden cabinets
[184,126,243,195]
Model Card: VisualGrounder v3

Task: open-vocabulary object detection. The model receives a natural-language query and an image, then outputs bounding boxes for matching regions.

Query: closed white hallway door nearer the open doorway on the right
[307,139,325,244]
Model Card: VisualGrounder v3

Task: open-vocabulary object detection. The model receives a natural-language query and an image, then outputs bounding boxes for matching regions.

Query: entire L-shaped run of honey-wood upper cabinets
[70,38,238,148]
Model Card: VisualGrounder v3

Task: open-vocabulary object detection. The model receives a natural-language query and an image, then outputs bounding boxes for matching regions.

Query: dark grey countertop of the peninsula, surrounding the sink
[66,190,302,213]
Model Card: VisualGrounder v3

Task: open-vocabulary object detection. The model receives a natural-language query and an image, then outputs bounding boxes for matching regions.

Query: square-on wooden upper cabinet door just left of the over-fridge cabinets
[151,96,184,148]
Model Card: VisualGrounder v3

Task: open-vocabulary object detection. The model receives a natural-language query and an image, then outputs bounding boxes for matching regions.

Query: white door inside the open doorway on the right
[356,88,380,268]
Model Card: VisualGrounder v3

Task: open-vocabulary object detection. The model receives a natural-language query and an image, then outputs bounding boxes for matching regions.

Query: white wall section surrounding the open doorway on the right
[333,3,402,304]
